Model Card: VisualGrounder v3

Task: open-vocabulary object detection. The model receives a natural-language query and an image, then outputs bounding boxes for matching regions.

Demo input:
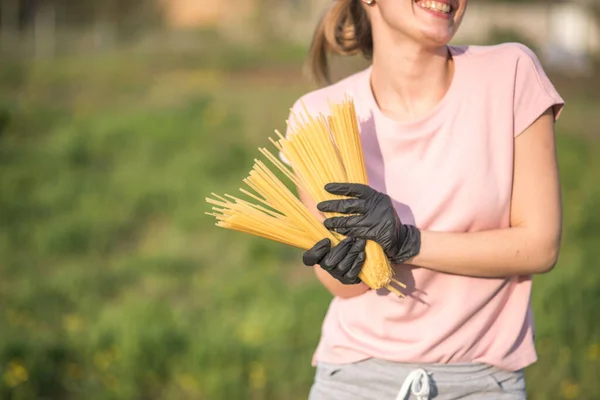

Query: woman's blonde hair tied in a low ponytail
[308,0,373,85]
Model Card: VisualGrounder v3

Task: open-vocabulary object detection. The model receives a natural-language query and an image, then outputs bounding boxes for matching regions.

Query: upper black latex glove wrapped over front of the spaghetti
[317,183,421,264]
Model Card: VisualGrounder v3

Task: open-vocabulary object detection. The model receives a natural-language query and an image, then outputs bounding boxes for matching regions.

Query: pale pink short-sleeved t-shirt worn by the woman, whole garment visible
[284,43,563,370]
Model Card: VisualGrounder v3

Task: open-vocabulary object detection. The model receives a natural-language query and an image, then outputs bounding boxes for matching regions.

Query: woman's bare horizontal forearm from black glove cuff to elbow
[409,227,560,278]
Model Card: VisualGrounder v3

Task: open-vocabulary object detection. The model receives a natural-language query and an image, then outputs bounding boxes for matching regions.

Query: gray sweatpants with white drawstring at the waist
[309,359,526,400]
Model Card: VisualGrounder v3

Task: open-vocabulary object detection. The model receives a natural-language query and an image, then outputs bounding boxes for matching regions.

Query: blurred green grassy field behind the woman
[0,35,600,400]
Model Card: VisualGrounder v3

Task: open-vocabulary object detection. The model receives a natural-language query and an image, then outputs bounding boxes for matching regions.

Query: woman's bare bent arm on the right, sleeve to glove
[409,109,562,277]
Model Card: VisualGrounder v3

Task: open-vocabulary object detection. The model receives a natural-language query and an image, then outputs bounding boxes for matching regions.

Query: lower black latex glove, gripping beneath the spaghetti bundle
[302,238,367,285]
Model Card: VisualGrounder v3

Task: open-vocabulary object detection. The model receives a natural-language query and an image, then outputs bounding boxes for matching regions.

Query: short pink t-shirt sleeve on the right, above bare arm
[513,45,565,137]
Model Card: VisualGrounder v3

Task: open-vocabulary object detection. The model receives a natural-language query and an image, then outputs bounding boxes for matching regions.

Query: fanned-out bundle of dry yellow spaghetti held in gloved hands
[206,98,405,296]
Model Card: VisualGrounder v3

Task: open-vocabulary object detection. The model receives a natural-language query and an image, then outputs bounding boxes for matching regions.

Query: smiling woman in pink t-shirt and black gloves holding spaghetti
[284,0,563,400]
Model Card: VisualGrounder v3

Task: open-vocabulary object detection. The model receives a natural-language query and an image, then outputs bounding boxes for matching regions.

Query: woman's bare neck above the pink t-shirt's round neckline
[371,35,454,120]
